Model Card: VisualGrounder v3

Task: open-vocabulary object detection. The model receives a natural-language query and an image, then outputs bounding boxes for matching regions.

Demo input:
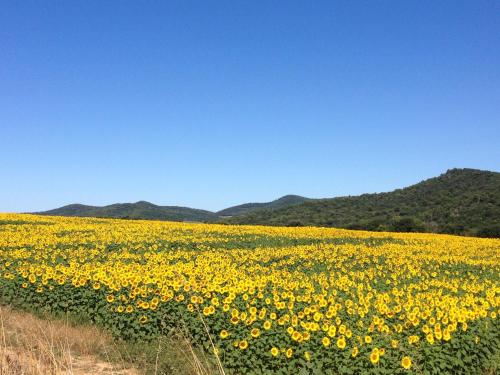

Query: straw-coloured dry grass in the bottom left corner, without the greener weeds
[0,306,139,375]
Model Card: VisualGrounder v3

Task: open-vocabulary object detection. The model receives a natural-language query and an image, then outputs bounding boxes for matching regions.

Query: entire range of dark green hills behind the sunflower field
[35,169,500,237]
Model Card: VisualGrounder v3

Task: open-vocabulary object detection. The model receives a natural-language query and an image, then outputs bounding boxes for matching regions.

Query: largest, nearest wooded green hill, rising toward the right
[225,169,500,237]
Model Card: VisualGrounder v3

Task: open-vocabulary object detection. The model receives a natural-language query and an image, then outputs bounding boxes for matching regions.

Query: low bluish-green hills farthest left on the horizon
[37,201,217,222]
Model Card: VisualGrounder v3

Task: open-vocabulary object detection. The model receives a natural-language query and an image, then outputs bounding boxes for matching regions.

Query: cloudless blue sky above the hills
[0,0,500,211]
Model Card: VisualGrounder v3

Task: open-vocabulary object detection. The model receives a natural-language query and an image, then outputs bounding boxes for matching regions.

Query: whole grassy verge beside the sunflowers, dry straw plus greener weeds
[0,305,224,375]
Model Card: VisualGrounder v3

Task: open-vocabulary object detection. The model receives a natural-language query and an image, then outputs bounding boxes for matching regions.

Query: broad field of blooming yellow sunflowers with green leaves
[0,214,500,374]
